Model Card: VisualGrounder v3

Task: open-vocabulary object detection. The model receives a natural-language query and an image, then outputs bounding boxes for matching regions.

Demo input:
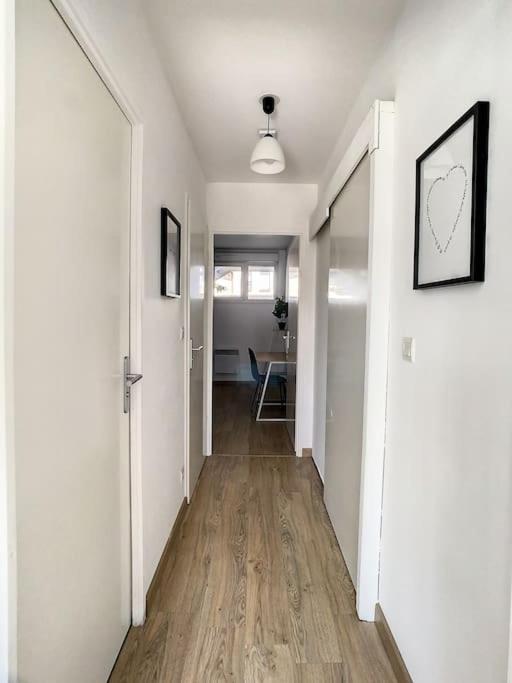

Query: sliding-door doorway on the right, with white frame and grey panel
[310,101,394,621]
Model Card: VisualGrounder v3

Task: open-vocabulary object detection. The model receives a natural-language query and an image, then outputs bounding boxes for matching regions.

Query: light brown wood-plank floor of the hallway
[110,456,396,683]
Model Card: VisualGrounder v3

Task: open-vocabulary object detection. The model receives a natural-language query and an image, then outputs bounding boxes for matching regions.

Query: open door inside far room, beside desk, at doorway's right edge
[285,237,300,448]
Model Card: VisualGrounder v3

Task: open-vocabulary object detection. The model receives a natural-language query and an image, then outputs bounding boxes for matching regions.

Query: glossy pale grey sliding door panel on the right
[325,156,370,583]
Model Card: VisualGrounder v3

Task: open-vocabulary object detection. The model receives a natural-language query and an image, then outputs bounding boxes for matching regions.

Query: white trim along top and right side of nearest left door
[41,0,146,626]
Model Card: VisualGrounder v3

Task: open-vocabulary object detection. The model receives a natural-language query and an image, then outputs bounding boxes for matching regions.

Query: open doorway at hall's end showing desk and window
[211,234,299,456]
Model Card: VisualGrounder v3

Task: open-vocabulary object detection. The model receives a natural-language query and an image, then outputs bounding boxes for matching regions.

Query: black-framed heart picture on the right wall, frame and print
[414,102,489,289]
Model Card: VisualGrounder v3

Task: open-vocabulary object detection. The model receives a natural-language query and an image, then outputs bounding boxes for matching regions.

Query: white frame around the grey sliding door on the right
[309,100,394,621]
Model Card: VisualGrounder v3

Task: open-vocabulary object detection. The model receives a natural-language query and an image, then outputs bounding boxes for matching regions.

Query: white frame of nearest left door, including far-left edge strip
[0,0,146,664]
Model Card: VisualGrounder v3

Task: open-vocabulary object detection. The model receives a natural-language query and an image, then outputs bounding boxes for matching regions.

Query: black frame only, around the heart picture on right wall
[413,101,490,290]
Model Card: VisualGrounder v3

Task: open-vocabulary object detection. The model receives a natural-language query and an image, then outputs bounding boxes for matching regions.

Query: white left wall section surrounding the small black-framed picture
[65,0,205,590]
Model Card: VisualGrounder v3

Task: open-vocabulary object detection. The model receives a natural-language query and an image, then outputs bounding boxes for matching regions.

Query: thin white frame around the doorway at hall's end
[204,228,309,457]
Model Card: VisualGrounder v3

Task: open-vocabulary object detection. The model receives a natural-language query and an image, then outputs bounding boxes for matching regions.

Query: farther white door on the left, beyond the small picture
[186,202,206,501]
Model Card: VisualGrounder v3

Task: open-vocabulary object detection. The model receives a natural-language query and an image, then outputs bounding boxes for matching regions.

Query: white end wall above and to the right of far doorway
[206,183,317,453]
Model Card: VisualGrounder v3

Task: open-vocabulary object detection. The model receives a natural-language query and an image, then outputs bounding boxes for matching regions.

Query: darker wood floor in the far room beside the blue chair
[213,382,294,455]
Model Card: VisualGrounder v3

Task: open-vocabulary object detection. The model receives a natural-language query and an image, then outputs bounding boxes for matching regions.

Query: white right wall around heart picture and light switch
[322,0,512,683]
